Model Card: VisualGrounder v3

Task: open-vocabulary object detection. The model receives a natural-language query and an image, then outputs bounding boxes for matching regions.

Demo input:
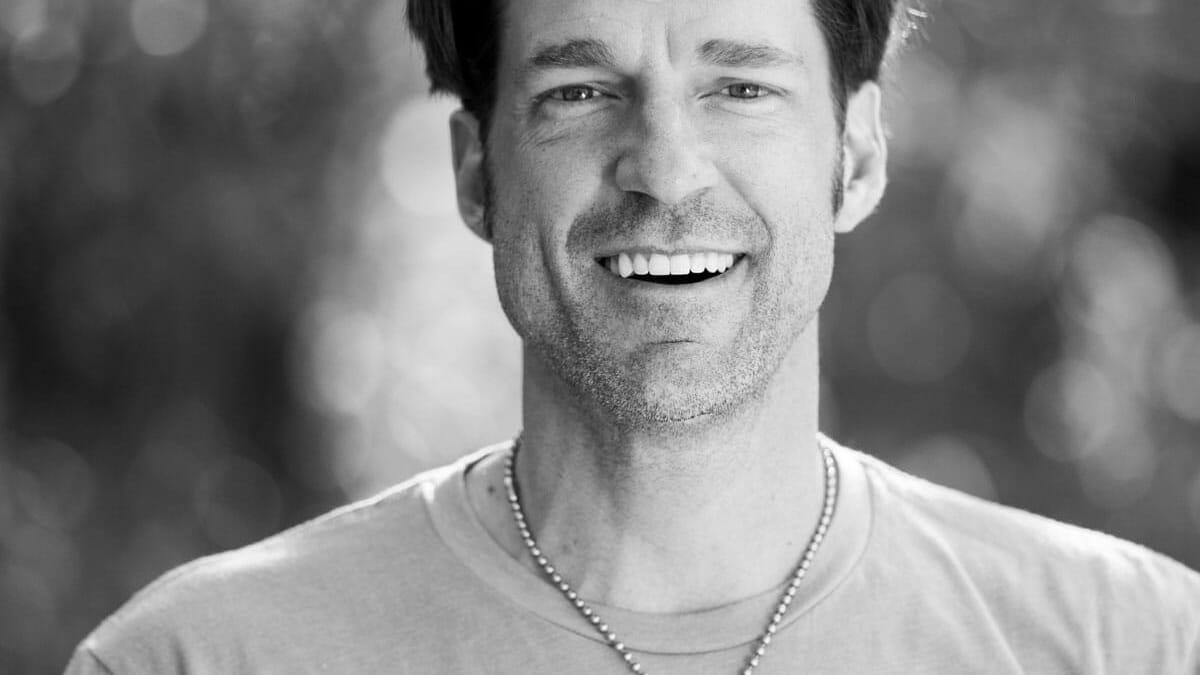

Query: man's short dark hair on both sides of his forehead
[408,0,918,133]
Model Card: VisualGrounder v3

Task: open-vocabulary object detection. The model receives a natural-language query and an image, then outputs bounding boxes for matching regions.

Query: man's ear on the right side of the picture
[834,82,888,233]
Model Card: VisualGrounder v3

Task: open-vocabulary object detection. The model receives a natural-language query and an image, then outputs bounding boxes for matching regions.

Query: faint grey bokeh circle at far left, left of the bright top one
[8,26,80,104]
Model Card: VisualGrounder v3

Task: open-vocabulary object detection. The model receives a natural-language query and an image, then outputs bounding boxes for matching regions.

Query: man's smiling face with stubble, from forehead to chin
[465,0,864,426]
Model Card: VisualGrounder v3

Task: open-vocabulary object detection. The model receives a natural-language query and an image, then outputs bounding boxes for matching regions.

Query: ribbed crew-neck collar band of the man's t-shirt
[425,437,872,655]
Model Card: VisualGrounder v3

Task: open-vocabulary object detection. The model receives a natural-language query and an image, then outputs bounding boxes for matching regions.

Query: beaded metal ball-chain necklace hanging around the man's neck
[504,437,838,675]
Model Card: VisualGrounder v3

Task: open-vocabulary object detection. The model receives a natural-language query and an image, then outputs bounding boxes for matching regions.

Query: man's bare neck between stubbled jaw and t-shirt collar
[465,323,823,613]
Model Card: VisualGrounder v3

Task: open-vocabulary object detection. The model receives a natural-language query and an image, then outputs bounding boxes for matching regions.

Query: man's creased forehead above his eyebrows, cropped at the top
[500,0,827,72]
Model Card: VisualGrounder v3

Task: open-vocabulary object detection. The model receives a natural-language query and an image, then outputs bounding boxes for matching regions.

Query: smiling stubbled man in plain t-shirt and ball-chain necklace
[68,0,1200,674]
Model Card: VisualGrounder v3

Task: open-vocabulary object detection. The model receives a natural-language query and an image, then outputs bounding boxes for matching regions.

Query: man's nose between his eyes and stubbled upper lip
[617,97,716,205]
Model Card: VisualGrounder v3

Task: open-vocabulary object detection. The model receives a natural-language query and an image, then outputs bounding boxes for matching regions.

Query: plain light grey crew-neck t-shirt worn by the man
[60,444,1200,675]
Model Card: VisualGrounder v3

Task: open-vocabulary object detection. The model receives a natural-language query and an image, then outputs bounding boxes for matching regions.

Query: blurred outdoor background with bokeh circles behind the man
[0,0,1200,674]
